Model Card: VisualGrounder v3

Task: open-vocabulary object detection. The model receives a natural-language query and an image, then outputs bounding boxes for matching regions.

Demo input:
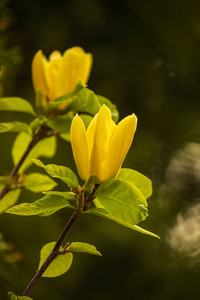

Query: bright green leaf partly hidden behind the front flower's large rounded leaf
[117,168,152,199]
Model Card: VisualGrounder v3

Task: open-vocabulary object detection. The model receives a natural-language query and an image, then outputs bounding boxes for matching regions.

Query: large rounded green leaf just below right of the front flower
[94,179,147,225]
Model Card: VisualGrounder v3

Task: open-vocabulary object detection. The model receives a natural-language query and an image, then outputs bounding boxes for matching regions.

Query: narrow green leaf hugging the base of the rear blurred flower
[49,81,85,111]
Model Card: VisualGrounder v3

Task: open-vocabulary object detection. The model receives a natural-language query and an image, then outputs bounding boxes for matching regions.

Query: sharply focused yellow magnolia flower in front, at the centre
[71,105,137,182]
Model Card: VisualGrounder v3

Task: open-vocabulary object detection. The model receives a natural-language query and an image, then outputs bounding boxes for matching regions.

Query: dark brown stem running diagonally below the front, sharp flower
[22,211,81,296]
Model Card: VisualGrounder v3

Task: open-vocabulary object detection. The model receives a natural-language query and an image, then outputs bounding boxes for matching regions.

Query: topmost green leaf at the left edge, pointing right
[0,97,36,116]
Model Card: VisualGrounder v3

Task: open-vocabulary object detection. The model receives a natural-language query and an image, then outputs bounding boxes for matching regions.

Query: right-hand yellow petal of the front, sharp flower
[100,114,137,181]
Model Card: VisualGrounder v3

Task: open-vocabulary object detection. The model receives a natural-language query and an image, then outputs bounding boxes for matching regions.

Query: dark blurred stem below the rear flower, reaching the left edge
[0,126,54,200]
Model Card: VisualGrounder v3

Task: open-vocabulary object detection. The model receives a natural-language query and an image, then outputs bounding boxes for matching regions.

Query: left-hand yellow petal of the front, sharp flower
[70,115,89,181]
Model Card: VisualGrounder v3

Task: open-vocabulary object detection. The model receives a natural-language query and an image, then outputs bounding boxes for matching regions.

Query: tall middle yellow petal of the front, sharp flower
[87,105,111,179]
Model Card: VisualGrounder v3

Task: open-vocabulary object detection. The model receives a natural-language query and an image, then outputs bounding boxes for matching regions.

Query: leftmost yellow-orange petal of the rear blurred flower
[32,50,49,96]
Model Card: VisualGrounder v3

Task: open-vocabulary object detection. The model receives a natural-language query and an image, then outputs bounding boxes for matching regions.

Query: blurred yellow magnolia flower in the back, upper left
[32,47,92,101]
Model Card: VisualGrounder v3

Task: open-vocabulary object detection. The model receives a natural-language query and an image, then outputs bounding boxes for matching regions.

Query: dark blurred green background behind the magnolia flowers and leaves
[0,0,200,300]
